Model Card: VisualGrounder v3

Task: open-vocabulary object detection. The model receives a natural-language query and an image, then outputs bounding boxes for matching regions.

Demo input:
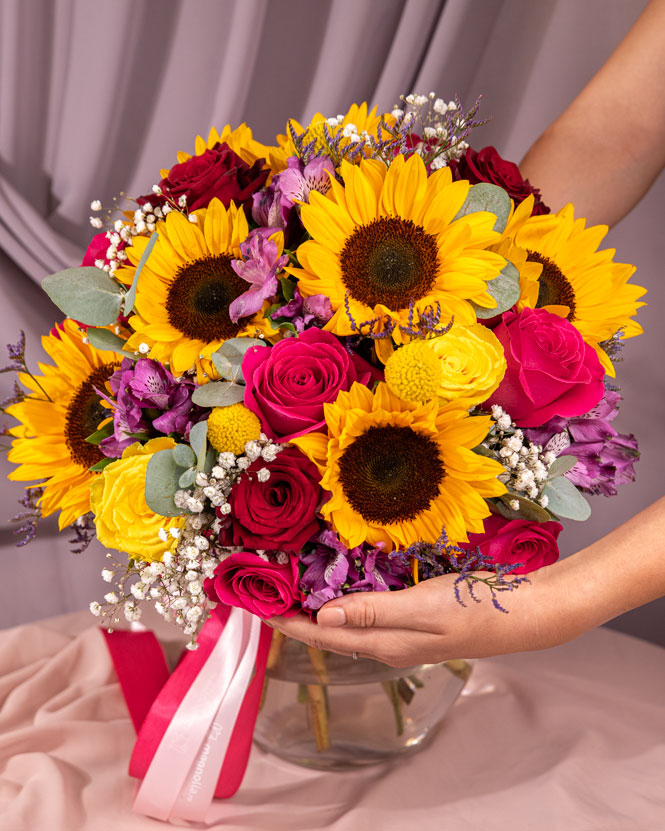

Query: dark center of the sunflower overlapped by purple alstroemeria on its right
[166,254,249,343]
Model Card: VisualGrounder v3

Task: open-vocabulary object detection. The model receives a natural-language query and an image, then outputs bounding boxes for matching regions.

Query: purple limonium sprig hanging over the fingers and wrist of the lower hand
[392,528,529,614]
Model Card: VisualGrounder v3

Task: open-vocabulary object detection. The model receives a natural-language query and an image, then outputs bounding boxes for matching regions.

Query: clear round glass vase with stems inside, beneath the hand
[254,633,472,770]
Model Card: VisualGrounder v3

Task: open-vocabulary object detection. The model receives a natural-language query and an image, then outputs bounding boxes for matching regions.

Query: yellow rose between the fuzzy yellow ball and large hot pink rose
[426,323,506,407]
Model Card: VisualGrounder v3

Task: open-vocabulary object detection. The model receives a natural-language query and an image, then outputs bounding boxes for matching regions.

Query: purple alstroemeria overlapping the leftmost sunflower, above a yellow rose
[99,358,202,458]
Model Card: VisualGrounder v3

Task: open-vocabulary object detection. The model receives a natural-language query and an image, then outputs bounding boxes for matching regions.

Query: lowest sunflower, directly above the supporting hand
[291,383,505,550]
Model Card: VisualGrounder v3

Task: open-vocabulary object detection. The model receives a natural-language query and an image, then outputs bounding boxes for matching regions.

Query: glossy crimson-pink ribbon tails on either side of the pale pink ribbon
[102,606,272,799]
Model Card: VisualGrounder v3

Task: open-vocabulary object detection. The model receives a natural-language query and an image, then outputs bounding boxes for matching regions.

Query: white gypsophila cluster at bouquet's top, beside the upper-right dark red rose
[392,92,469,170]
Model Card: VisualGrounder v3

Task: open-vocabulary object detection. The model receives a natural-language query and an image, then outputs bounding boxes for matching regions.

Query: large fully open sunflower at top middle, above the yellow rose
[287,155,505,356]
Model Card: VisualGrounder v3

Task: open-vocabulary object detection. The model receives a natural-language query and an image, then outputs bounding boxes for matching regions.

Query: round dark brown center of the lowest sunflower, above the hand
[339,426,445,525]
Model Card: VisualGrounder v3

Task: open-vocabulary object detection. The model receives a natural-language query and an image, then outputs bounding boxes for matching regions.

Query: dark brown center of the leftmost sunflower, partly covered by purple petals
[65,363,119,468]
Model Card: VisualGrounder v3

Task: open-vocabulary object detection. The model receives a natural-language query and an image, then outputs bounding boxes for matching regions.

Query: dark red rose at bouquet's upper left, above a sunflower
[136,142,270,213]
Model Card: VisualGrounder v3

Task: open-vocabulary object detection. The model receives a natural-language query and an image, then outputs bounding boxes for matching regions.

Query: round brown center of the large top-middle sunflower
[340,217,439,311]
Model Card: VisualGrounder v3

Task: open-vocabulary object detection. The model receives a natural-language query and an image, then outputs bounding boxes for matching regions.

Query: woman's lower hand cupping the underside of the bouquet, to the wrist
[268,562,584,667]
